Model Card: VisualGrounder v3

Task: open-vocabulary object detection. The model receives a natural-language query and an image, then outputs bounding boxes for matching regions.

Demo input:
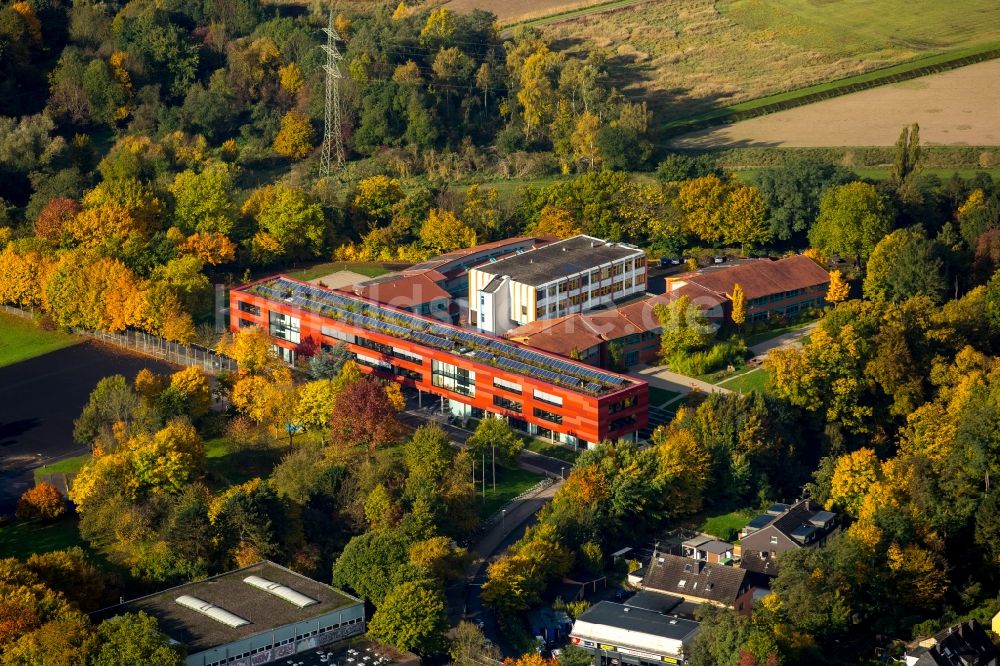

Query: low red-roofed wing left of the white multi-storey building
[343,236,555,323]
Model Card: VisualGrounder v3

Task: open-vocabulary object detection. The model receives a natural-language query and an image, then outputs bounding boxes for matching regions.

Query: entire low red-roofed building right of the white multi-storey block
[667,255,830,322]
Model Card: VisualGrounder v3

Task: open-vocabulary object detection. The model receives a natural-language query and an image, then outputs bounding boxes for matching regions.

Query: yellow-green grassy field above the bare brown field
[536,0,1000,122]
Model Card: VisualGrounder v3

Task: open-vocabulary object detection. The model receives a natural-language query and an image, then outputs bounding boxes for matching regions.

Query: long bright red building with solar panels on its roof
[229,276,649,446]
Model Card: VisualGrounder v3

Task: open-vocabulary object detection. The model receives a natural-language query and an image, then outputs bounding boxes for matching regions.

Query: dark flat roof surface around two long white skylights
[98,561,363,653]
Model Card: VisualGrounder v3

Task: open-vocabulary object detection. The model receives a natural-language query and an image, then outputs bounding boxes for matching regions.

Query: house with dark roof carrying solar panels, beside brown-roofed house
[739,499,839,577]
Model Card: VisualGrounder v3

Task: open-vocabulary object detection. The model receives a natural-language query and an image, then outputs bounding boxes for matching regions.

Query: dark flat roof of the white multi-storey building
[476,235,643,287]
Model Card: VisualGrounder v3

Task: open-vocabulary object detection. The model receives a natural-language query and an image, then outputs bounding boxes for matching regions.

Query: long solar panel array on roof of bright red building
[250,277,629,393]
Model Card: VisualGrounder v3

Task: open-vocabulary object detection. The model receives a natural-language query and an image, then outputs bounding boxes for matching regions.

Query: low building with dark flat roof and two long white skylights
[99,562,365,666]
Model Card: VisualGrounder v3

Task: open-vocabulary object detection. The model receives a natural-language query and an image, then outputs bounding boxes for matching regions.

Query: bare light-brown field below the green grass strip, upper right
[671,60,1000,148]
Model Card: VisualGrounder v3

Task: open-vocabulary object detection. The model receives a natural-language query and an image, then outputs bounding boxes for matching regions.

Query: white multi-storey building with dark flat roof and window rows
[469,236,647,334]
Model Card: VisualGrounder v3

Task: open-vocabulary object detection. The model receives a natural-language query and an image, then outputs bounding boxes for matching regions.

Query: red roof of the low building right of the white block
[668,254,830,299]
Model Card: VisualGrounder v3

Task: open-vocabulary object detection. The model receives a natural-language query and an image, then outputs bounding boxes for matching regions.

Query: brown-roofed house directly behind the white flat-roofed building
[640,553,754,614]
